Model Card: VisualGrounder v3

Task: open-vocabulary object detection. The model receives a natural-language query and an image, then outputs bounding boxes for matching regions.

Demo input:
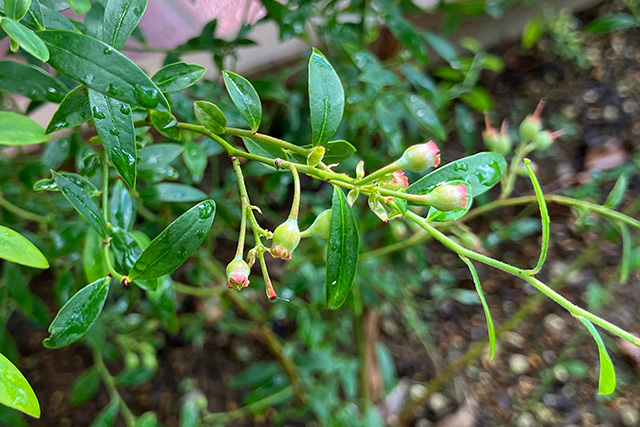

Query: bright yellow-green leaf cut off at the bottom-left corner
[0,353,40,418]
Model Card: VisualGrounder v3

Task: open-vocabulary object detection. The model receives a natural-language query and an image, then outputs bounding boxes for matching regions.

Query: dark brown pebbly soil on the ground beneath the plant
[9,0,640,427]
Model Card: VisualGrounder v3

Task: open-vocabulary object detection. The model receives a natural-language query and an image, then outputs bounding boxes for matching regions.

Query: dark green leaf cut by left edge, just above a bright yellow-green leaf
[0,61,68,103]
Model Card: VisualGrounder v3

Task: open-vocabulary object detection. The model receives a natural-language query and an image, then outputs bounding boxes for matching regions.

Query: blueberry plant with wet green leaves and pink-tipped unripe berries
[0,0,640,426]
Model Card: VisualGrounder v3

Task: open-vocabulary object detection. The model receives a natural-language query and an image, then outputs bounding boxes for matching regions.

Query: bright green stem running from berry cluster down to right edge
[406,211,640,346]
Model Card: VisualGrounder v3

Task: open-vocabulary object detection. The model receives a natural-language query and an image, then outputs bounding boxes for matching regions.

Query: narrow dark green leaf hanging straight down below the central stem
[326,187,360,310]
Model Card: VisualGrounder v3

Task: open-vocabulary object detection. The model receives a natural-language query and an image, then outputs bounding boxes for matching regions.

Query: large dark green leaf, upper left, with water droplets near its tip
[38,30,170,111]
